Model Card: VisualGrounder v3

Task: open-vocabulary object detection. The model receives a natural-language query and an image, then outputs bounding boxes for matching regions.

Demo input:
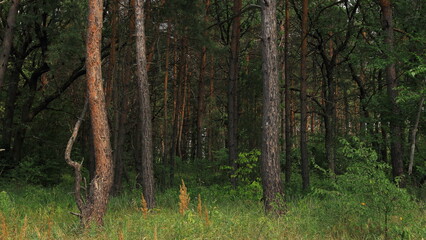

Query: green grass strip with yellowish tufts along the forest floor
[0,185,426,239]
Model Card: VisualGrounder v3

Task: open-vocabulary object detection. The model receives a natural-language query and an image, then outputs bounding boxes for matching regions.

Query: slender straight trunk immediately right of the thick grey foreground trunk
[284,0,293,184]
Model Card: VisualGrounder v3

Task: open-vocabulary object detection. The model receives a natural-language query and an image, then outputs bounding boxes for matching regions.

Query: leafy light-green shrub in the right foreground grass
[312,140,420,239]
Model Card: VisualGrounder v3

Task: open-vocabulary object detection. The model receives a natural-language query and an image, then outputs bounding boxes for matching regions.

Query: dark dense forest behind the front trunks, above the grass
[0,0,426,237]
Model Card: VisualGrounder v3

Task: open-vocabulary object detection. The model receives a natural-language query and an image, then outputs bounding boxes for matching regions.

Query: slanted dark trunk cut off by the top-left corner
[0,0,20,88]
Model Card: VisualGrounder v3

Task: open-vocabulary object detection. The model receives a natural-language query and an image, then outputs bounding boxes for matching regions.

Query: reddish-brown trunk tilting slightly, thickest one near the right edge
[379,0,404,180]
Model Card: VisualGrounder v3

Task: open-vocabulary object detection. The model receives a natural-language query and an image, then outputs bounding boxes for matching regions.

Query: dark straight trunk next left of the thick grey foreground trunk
[227,0,242,186]
